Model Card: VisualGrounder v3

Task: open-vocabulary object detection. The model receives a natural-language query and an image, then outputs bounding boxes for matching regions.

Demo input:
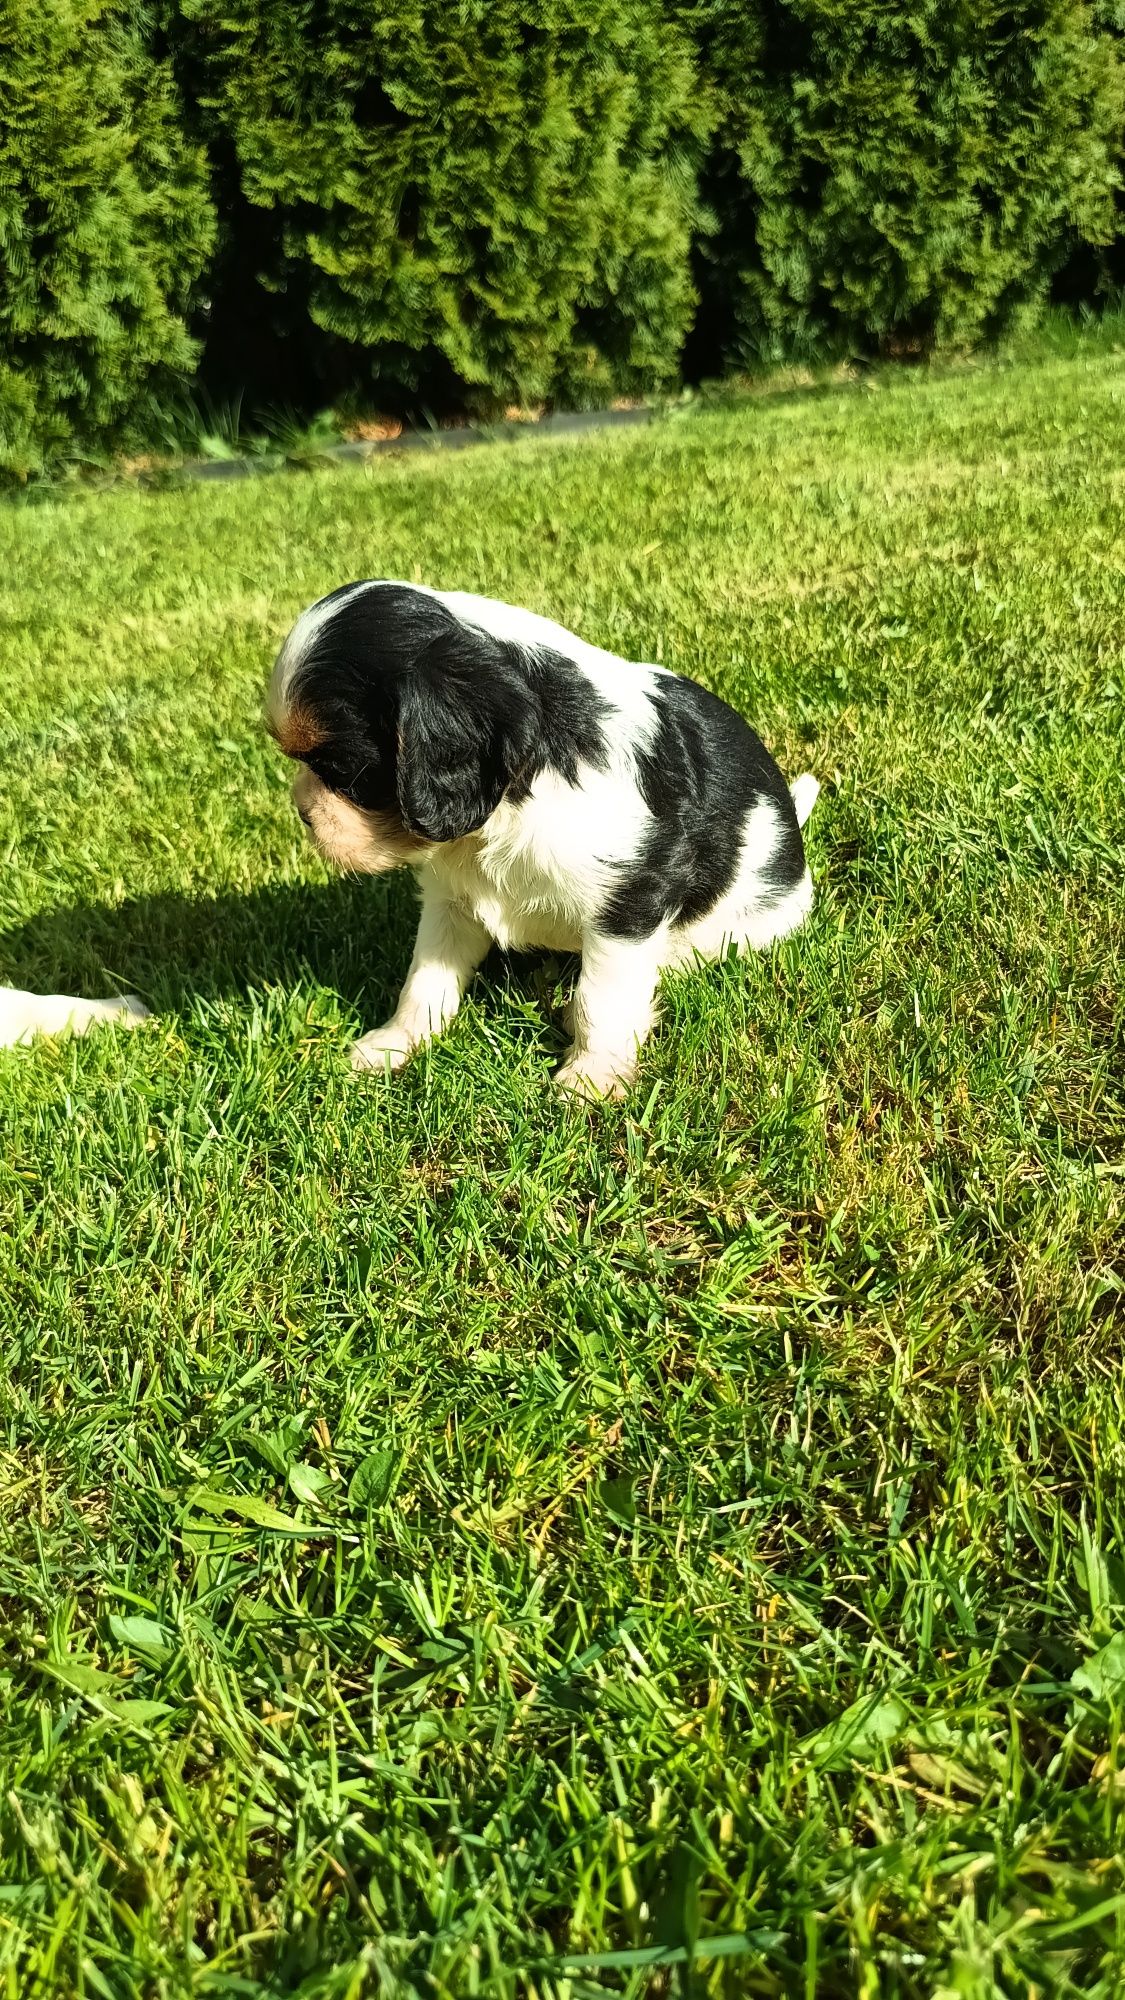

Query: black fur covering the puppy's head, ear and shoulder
[290,584,607,840]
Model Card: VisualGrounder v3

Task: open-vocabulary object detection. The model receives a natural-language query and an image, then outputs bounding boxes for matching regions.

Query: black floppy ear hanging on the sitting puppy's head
[398,642,510,840]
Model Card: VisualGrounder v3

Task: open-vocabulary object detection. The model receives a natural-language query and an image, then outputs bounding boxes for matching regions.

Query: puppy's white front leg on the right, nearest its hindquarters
[554,930,667,1098]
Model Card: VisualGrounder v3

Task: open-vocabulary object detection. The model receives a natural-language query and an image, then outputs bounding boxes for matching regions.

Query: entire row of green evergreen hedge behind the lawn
[0,0,1125,476]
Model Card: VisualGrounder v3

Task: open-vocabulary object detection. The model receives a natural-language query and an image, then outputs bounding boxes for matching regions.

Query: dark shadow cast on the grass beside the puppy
[0,874,564,1022]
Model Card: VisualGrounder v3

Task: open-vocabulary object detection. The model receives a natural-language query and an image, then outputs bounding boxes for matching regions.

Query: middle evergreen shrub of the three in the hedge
[180,0,703,400]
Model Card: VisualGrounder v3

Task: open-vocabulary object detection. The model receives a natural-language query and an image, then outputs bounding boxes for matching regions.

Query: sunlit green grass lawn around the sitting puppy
[0,338,1125,2000]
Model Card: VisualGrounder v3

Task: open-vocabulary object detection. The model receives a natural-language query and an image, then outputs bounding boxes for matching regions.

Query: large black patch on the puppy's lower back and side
[599,674,805,938]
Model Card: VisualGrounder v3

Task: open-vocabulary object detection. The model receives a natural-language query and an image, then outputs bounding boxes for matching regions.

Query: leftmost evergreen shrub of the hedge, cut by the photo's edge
[0,0,214,476]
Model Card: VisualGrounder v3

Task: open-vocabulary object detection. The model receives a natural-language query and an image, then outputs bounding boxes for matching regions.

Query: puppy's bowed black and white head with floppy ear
[266,584,530,874]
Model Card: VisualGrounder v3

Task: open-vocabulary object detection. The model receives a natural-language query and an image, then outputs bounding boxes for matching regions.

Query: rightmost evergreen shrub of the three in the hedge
[691,0,1123,364]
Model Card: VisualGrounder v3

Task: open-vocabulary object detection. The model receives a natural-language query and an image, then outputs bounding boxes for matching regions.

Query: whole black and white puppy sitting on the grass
[266,582,819,1096]
